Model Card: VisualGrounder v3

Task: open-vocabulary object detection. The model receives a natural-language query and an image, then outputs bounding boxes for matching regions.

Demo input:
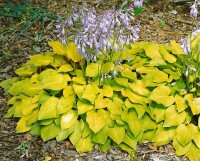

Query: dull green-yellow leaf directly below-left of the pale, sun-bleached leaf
[41,122,60,141]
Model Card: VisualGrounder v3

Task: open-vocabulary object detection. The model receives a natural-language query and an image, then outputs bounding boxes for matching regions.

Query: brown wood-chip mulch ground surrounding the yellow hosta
[0,0,198,161]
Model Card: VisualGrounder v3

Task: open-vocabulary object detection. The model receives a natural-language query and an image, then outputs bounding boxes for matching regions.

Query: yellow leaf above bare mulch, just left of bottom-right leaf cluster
[152,124,176,146]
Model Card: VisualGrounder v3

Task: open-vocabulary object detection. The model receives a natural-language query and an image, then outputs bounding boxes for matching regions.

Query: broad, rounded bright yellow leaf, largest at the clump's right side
[149,85,174,107]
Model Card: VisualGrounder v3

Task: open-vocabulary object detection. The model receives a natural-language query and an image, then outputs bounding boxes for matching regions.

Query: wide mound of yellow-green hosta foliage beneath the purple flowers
[1,41,200,161]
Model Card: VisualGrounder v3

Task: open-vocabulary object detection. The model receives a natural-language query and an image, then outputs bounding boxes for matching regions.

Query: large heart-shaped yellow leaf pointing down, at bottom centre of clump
[86,109,107,134]
